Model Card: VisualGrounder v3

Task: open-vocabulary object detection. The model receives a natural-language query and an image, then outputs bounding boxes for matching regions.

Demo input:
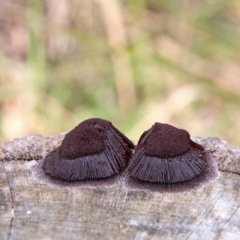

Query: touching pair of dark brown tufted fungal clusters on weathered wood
[43,118,214,189]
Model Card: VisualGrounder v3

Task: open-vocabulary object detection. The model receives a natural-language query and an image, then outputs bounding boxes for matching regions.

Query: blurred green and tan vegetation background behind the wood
[0,0,240,146]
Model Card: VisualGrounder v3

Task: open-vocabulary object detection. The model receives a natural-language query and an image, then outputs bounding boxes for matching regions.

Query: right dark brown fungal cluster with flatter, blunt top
[128,123,207,184]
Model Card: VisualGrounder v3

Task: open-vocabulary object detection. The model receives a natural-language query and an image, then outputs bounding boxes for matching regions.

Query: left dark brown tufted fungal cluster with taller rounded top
[43,118,135,181]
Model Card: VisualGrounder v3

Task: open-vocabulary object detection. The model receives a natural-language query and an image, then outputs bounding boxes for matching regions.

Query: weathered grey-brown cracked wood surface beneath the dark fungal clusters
[0,135,240,240]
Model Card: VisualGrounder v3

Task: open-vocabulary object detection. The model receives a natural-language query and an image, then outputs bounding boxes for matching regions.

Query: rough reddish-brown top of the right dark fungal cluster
[146,123,190,158]
